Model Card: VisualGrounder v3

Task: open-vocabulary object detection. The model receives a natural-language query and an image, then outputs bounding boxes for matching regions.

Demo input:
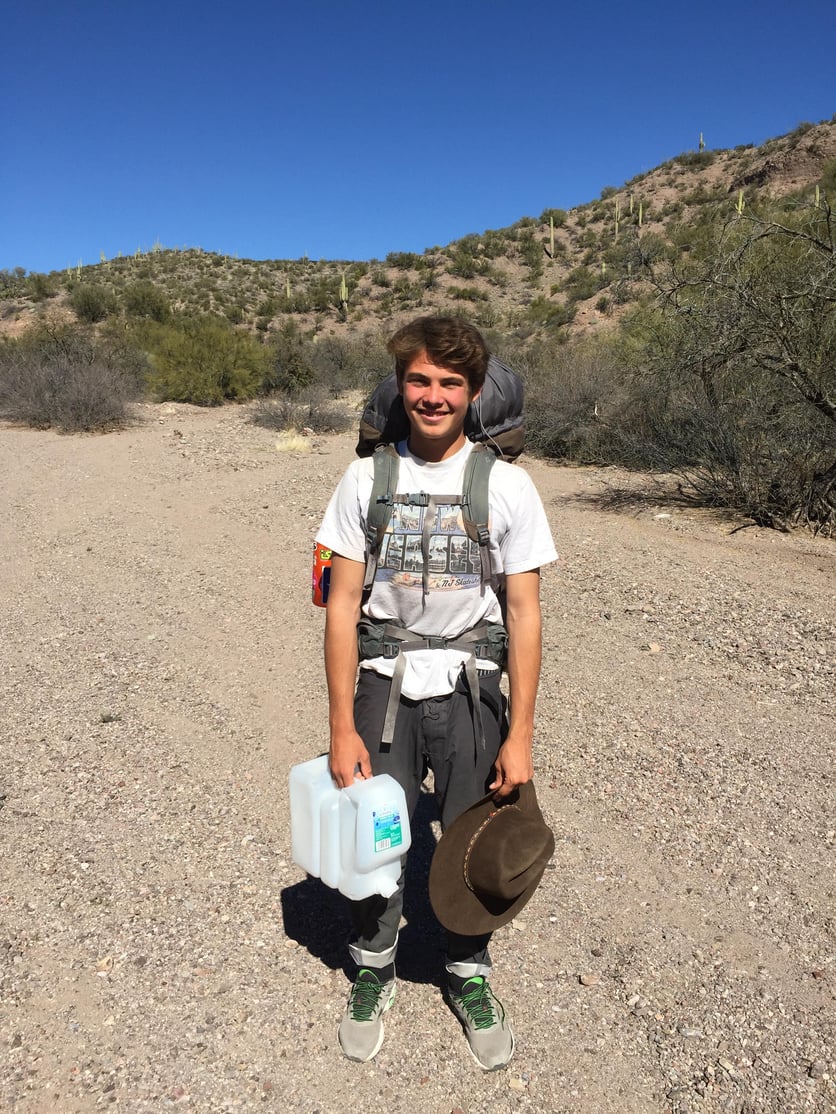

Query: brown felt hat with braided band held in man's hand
[429,781,554,936]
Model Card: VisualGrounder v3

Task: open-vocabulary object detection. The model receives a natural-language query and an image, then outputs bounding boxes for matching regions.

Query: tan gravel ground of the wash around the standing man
[0,405,836,1114]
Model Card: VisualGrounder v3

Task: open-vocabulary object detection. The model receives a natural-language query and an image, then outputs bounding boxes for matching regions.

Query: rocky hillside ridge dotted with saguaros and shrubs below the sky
[0,117,836,340]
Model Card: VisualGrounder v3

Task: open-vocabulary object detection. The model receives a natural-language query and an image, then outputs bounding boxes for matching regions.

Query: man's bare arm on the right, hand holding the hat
[488,568,542,798]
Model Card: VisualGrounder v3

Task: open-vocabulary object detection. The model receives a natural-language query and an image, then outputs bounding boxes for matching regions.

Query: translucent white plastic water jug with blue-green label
[290,754,411,901]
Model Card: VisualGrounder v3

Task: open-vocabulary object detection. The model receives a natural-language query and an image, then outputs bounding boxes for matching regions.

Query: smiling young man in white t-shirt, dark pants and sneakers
[317,317,556,1071]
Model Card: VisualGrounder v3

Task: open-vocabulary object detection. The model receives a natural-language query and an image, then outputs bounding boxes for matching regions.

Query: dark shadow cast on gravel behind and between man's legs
[281,789,446,986]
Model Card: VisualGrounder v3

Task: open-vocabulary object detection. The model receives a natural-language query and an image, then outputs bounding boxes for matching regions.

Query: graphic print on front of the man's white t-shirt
[378,502,480,592]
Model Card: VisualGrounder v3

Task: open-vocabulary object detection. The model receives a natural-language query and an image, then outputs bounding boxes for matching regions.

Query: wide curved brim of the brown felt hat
[429,781,554,936]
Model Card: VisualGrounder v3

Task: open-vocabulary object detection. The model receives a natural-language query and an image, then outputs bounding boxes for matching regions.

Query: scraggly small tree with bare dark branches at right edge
[633,203,836,529]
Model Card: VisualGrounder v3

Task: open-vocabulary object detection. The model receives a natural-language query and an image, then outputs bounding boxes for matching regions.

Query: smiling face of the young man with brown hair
[398,352,478,461]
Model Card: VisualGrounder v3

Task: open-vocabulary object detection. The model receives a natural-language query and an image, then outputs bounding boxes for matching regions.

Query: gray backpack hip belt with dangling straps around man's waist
[357,618,508,747]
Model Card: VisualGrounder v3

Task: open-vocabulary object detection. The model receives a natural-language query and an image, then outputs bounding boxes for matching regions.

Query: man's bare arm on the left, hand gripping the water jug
[324,554,371,789]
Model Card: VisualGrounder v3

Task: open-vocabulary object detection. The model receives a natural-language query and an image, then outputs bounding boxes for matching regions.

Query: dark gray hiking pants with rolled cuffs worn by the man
[349,670,507,978]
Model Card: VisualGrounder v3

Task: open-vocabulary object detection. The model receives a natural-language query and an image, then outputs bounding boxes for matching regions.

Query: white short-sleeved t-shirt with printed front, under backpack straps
[317,441,557,700]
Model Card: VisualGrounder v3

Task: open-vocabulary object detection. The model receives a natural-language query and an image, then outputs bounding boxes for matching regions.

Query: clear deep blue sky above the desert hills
[0,0,836,271]
